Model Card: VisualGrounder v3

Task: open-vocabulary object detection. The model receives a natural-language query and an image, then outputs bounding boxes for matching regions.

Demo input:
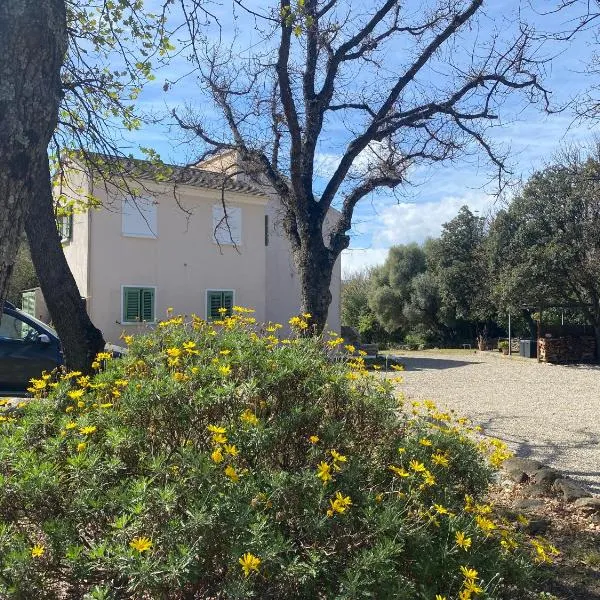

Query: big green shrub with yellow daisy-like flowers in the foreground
[0,310,554,600]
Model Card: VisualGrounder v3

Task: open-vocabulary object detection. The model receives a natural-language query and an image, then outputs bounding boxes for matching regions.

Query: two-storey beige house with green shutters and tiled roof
[59,152,341,344]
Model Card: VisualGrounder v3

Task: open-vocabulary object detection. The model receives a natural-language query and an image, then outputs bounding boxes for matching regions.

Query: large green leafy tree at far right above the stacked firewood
[490,150,600,349]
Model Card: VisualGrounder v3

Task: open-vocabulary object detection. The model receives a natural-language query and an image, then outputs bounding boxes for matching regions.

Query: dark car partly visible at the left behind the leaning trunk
[0,302,63,393]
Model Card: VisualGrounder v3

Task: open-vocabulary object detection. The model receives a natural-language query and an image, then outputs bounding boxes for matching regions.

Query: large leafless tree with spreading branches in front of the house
[174,0,548,331]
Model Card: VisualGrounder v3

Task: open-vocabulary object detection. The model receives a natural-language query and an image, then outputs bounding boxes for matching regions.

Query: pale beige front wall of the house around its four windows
[88,184,266,344]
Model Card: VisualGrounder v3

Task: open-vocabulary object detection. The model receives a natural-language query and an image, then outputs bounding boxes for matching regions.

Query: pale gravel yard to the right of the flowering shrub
[384,351,600,493]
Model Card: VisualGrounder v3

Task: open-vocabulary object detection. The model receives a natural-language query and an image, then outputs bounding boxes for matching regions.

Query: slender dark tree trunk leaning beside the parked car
[25,155,105,373]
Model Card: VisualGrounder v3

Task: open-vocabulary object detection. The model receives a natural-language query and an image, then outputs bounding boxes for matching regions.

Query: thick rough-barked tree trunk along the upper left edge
[0,0,67,310]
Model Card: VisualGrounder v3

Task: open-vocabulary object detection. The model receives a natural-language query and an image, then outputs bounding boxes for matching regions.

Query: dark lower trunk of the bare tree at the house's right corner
[296,234,335,335]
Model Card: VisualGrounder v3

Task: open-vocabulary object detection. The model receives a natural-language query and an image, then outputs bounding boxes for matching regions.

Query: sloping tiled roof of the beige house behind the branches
[81,154,265,196]
